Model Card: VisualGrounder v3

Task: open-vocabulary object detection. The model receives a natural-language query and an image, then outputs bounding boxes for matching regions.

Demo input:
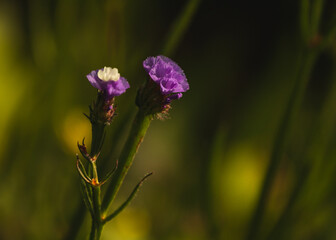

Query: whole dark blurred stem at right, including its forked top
[247,0,324,239]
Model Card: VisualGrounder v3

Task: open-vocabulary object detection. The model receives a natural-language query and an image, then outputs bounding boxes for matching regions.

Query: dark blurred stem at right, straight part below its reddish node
[246,49,317,240]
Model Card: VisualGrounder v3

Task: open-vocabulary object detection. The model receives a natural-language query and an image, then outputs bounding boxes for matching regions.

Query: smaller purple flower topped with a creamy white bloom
[86,67,130,100]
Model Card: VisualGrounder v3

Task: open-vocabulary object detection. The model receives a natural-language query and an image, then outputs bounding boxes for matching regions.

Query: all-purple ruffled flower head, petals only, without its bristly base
[143,55,189,103]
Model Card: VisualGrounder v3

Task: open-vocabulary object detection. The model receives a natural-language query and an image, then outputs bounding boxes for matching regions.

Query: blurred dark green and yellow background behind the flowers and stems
[0,0,336,240]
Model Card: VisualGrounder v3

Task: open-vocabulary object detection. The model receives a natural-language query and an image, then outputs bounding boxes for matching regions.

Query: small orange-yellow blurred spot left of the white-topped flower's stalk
[56,109,91,153]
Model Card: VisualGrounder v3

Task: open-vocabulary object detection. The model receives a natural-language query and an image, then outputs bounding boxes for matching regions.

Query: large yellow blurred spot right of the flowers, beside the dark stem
[213,144,266,218]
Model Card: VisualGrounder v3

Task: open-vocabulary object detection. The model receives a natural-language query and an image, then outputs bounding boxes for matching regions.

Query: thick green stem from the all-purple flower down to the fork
[102,110,152,216]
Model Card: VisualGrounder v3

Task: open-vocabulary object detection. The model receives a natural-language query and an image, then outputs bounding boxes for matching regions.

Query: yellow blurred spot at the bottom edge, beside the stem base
[102,207,151,240]
